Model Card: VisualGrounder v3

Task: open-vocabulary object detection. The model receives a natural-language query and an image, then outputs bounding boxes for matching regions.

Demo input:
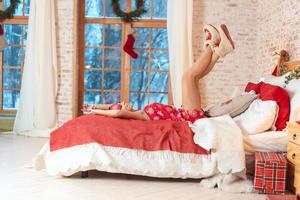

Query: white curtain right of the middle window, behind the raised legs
[167,0,193,107]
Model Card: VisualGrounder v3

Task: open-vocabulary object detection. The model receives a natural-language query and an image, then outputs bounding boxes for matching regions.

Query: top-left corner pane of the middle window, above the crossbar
[85,0,103,18]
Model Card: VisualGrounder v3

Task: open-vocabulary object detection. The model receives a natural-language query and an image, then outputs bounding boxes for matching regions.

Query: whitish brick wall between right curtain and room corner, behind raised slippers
[193,0,257,105]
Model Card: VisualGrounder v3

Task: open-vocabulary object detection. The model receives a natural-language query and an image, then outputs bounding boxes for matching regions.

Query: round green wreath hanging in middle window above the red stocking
[112,0,147,22]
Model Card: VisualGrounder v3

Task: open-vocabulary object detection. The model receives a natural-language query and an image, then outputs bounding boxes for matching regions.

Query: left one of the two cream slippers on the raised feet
[203,24,221,50]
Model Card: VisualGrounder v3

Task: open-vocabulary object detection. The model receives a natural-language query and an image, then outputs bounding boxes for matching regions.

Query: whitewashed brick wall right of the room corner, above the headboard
[257,0,300,76]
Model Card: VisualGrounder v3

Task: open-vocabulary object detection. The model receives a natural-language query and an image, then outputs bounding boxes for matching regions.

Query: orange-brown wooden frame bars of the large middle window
[78,0,170,110]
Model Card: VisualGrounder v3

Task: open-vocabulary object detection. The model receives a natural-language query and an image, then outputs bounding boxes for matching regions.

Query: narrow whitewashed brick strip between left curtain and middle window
[56,0,74,125]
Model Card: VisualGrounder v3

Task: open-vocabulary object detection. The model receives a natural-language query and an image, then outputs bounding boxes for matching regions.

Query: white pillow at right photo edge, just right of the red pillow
[285,79,300,121]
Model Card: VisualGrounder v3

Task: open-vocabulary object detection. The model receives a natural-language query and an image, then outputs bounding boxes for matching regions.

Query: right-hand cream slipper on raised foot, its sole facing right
[214,24,234,57]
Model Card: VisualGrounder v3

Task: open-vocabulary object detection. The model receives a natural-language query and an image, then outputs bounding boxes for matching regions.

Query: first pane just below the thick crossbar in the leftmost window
[3,25,22,45]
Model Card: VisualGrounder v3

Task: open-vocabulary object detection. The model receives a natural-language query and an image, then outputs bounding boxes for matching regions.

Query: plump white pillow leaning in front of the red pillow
[234,99,278,135]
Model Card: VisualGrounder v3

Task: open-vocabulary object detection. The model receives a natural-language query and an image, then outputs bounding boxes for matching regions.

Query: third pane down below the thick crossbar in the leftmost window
[3,69,21,88]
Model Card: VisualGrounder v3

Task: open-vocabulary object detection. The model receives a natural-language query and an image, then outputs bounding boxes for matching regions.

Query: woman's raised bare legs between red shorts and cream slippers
[182,47,217,111]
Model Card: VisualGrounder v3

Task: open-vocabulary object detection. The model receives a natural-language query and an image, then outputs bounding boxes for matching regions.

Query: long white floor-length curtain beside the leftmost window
[14,0,57,137]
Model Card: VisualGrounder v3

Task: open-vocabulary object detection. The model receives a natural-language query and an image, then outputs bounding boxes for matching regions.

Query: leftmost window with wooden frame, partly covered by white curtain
[0,0,30,114]
